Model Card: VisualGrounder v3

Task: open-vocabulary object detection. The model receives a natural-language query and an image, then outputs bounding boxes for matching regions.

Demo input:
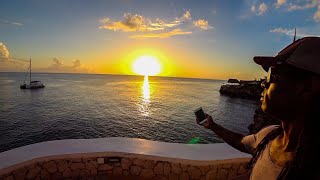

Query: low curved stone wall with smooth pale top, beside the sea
[0,137,250,180]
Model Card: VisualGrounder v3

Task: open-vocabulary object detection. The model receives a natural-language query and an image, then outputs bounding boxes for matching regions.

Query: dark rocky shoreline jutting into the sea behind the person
[219,79,280,134]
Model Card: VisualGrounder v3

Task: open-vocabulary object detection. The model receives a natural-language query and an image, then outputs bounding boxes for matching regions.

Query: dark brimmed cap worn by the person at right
[253,37,320,74]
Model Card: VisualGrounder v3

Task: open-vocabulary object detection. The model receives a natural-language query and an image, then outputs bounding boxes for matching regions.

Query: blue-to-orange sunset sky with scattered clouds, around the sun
[0,0,320,79]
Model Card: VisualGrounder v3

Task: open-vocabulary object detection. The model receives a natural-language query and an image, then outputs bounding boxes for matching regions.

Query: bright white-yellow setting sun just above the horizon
[132,56,161,76]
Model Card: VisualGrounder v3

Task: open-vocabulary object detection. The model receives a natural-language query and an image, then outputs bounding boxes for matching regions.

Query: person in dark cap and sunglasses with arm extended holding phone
[198,37,320,180]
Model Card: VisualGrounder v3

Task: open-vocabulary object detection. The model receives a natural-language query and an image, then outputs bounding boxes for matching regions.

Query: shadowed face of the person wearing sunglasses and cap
[260,67,301,120]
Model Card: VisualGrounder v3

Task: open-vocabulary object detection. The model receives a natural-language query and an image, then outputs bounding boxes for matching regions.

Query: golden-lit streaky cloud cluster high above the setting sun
[99,10,212,39]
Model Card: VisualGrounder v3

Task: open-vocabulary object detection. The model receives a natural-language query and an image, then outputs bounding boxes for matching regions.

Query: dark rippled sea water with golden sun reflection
[0,73,258,152]
